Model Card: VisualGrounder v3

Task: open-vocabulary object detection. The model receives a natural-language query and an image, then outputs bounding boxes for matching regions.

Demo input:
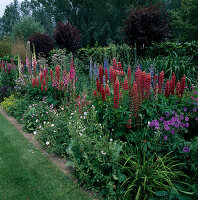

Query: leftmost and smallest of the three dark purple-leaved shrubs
[29,32,54,56]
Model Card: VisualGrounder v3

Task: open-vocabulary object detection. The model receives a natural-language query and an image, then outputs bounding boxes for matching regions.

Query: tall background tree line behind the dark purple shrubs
[0,0,198,47]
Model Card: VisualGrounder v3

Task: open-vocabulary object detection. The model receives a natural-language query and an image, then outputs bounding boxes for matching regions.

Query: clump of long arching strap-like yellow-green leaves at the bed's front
[122,148,188,200]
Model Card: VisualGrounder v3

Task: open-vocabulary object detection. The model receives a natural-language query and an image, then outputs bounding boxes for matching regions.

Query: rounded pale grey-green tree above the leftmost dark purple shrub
[12,17,45,41]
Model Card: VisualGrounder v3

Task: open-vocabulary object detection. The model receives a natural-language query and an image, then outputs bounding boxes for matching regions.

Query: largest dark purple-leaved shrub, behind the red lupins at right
[124,4,169,54]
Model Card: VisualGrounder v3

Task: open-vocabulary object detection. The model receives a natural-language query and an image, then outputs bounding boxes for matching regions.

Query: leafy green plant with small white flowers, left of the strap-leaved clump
[67,108,125,199]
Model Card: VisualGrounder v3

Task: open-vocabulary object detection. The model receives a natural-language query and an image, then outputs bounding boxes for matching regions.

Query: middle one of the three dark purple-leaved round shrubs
[53,22,80,53]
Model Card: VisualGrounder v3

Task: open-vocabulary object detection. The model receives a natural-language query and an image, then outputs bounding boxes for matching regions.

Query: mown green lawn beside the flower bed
[0,114,90,200]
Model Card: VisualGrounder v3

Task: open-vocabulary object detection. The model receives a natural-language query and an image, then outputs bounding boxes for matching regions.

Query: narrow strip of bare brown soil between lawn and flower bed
[0,107,98,200]
